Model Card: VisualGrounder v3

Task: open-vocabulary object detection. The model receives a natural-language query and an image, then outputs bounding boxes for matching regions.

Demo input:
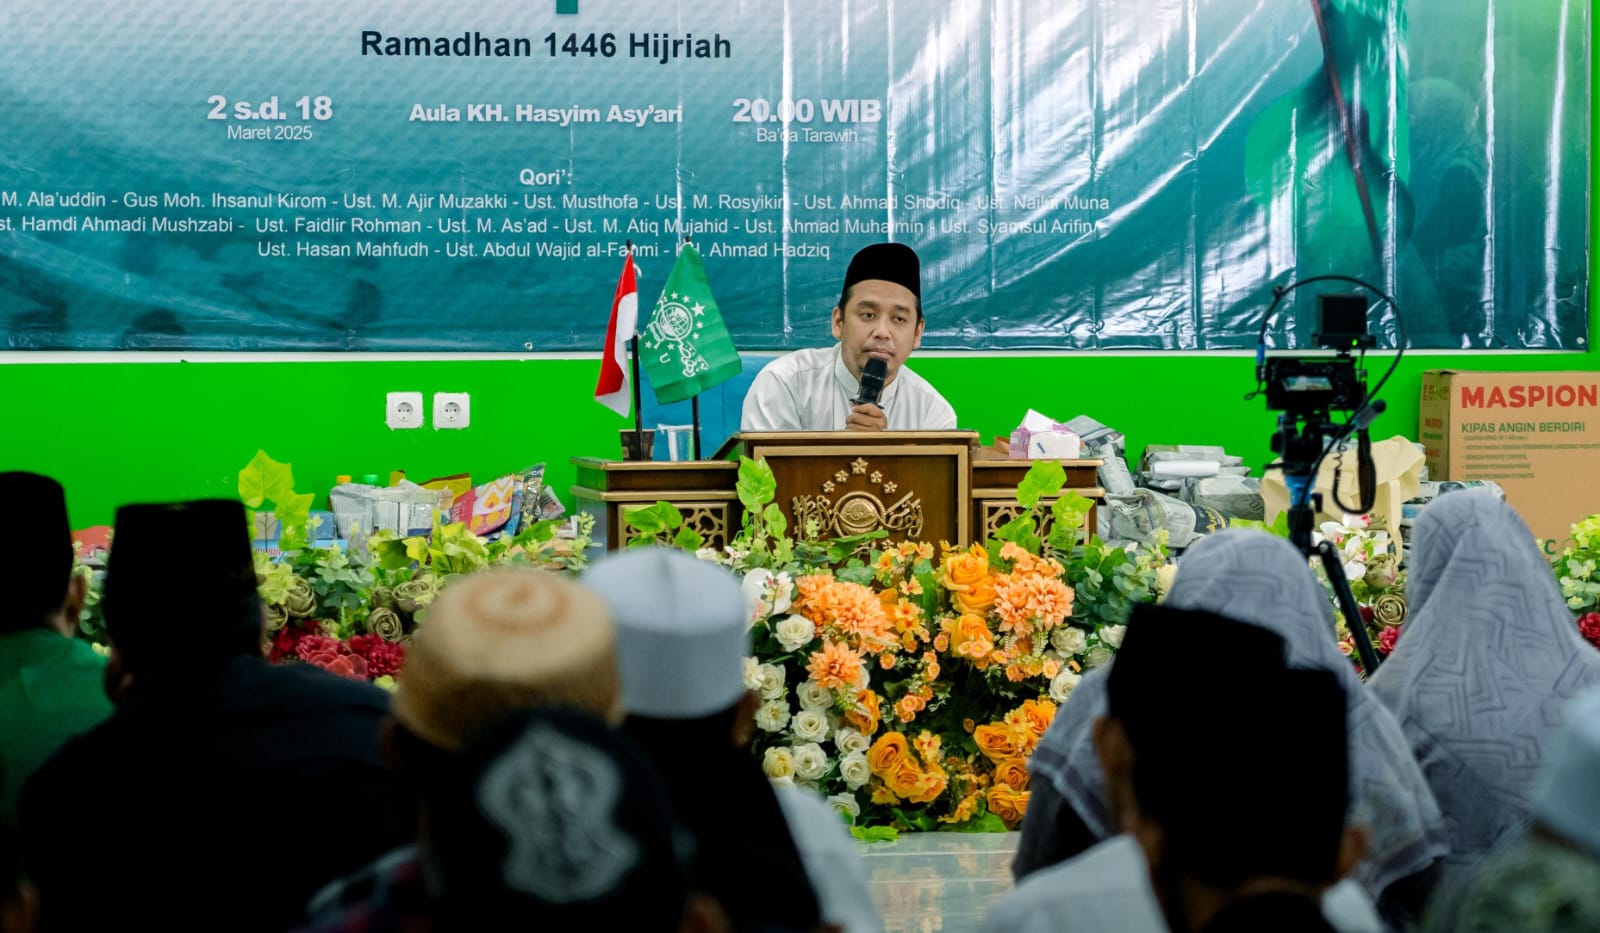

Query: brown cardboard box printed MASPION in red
[1418,370,1600,555]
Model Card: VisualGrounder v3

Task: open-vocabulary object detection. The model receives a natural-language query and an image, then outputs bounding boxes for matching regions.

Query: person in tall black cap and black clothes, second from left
[21,501,413,930]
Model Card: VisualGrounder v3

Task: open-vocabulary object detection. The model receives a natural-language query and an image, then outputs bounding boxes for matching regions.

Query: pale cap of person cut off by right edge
[1533,687,1600,859]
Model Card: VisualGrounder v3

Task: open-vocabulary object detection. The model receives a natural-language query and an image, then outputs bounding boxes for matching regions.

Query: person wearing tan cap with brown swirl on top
[310,568,621,933]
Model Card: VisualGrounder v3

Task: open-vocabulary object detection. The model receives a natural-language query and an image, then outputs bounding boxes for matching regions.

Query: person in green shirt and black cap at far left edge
[0,472,110,823]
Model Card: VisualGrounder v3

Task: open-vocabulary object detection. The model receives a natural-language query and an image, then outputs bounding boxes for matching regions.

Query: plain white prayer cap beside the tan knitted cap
[582,547,749,719]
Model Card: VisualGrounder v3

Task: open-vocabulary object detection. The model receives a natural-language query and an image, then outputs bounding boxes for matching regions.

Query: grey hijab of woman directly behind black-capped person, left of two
[1029,530,1445,901]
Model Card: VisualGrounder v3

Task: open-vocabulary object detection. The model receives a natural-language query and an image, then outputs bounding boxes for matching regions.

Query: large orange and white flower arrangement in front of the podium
[720,459,1166,837]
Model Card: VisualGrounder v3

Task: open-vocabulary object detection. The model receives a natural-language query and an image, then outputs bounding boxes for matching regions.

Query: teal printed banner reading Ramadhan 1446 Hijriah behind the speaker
[0,0,1590,352]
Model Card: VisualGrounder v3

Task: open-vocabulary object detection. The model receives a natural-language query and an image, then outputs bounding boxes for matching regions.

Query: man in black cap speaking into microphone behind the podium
[739,243,955,430]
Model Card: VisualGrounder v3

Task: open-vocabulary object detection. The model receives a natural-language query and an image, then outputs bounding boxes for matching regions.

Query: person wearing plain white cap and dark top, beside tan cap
[584,549,857,931]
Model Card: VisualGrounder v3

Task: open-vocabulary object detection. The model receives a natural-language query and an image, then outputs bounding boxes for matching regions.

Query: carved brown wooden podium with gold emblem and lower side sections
[571,430,1106,551]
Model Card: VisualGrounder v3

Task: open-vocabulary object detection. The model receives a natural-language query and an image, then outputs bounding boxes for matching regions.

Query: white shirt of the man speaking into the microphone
[739,344,955,430]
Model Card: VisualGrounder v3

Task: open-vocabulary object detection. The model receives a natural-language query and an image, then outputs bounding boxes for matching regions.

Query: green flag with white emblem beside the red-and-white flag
[638,243,742,405]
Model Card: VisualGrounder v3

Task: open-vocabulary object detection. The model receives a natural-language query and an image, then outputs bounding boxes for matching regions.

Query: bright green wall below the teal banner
[0,31,1600,527]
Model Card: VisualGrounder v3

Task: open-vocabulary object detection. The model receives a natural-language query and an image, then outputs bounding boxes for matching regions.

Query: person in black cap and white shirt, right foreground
[984,607,1382,933]
